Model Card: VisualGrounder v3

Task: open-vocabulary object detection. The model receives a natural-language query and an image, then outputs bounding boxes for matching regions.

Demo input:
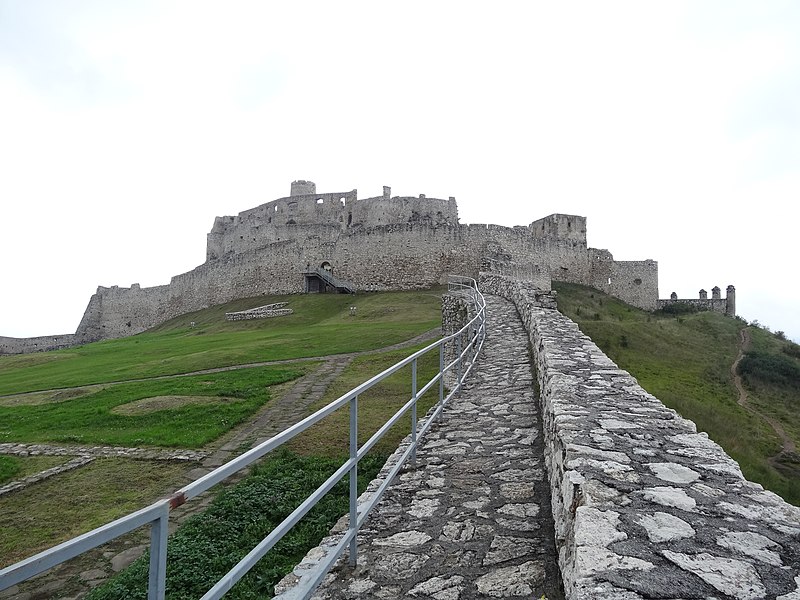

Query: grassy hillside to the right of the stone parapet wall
[553,282,800,504]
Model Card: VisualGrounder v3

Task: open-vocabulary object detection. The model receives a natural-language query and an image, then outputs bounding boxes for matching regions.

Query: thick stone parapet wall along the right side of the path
[481,278,800,600]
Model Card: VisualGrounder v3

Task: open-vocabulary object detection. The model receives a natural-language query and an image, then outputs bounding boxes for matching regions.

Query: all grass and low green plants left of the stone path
[0,290,441,598]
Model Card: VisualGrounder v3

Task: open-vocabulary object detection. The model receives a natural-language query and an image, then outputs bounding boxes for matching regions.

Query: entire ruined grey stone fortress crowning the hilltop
[0,181,658,354]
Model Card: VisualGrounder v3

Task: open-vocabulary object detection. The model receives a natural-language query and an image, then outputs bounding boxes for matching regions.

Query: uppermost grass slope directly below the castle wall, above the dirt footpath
[0,290,441,394]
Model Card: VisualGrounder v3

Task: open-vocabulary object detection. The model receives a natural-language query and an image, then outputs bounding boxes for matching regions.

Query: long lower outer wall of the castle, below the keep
[67,223,658,342]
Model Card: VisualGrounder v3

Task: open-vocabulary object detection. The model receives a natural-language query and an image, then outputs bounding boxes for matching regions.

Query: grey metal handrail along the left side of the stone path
[0,276,486,600]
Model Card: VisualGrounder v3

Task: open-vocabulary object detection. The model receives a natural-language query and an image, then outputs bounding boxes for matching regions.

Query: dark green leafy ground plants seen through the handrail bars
[86,452,386,600]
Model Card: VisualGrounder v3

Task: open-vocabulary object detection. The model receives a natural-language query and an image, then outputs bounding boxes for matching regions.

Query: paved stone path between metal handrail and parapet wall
[315,296,563,600]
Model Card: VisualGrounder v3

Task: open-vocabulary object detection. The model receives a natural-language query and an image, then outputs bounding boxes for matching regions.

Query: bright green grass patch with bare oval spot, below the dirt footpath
[0,363,309,448]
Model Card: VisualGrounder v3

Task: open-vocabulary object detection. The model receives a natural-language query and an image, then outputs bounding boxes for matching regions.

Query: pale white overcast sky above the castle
[0,0,800,340]
